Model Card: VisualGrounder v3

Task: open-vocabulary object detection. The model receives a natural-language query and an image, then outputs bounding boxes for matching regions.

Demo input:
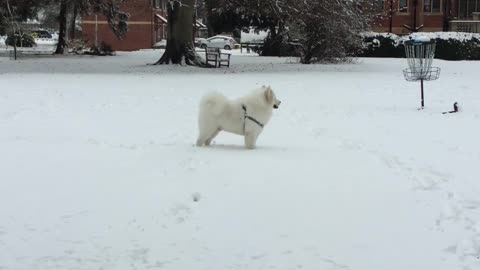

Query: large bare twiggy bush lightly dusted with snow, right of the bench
[288,0,372,64]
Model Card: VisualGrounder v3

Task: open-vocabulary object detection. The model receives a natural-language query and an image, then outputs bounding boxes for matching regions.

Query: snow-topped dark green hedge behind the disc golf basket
[358,32,480,60]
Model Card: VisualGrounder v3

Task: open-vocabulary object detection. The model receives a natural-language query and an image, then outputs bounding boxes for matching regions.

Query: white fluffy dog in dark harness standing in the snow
[197,86,281,149]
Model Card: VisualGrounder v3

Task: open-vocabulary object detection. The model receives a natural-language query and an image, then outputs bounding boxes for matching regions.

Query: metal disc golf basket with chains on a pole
[403,37,440,109]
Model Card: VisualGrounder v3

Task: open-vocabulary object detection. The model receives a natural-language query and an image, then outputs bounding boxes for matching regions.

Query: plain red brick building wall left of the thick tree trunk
[82,0,167,51]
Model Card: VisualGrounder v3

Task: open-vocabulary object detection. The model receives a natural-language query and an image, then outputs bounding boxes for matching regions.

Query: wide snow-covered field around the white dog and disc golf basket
[0,50,480,270]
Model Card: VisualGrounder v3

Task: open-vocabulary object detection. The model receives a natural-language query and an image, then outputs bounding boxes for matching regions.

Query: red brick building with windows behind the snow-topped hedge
[373,0,480,34]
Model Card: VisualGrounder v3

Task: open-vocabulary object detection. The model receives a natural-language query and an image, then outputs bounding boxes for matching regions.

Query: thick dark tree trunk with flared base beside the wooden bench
[155,0,207,67]
